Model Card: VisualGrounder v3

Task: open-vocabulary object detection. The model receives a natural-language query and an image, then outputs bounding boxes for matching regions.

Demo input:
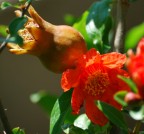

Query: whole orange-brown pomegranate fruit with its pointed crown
[8,6,87,73]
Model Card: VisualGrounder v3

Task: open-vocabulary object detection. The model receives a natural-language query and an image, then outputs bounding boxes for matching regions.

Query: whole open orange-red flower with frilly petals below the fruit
[61,48,128,126]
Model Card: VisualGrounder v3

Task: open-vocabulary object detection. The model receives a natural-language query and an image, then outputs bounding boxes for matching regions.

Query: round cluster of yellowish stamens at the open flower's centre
[84,71,109,97]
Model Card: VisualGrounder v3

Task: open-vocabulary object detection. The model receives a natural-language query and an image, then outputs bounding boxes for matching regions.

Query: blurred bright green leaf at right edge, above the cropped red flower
[125,23,144,52]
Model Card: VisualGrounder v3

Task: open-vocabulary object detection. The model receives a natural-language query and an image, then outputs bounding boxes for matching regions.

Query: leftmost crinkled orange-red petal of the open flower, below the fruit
[61,69,80,92]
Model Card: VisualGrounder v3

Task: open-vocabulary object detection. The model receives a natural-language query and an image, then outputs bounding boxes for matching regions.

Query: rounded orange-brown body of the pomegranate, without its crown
[39,26,87,73]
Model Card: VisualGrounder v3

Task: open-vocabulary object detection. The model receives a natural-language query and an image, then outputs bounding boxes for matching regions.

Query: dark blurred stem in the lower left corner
[0,100,12,134]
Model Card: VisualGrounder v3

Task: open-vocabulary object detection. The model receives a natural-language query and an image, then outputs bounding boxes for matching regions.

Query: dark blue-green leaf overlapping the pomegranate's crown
[9,17,27,36]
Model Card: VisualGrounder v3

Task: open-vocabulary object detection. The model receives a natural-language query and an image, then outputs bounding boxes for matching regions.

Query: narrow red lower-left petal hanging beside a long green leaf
[71,87,85,114]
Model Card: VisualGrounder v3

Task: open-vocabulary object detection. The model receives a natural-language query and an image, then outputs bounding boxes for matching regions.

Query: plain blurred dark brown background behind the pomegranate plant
[0,0,144,134]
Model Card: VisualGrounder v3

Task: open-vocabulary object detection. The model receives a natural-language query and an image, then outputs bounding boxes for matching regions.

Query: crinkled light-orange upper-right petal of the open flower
[101,52,126,68]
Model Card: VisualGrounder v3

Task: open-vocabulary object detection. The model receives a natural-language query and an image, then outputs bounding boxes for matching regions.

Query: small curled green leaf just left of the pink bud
[114,91,128,106]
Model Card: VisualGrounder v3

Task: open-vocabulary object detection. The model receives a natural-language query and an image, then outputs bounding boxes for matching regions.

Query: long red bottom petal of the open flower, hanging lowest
[85,98,108,126]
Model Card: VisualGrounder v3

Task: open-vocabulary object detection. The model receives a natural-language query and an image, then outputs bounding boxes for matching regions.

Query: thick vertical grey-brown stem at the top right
[113,0,129,53]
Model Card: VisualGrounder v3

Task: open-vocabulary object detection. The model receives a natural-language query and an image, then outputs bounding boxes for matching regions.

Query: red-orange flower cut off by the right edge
[126,38,144,99]
